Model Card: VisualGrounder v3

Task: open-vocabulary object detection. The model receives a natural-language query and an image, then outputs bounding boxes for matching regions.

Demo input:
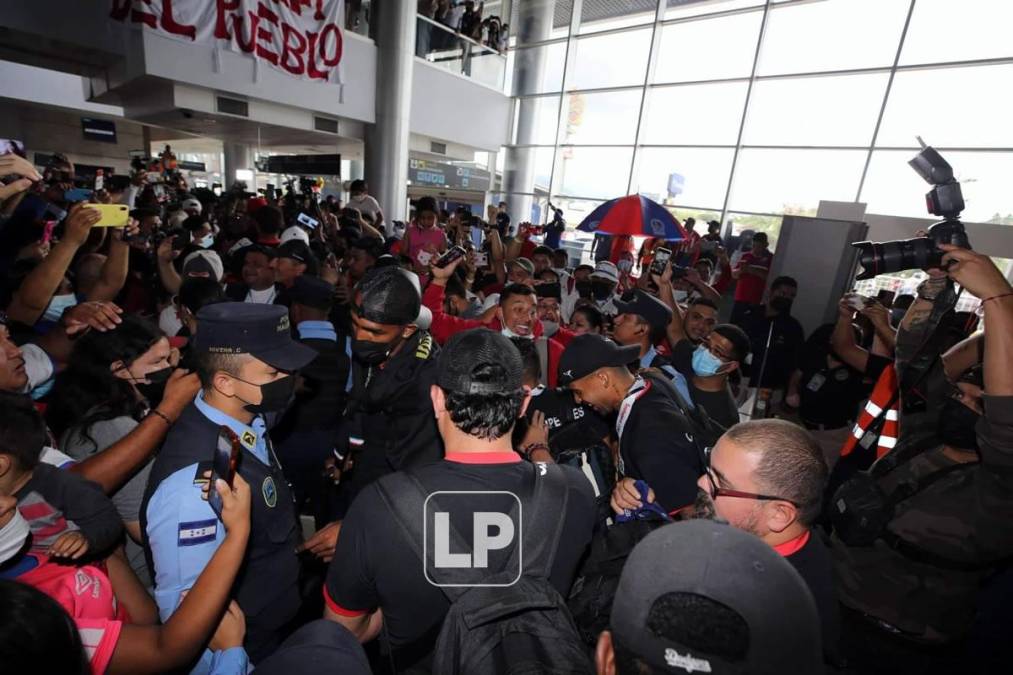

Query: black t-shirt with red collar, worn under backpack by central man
[326,453,595,669]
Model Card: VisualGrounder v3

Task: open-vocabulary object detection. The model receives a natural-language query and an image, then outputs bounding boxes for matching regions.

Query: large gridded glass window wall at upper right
[497,0,1013,238]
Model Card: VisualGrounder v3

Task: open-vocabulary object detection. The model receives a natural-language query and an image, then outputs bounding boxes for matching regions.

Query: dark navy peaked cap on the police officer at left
[193,302,317,372]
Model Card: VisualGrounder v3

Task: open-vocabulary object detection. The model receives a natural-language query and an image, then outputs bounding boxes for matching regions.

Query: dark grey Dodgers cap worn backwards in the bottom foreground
[611,520,823,675]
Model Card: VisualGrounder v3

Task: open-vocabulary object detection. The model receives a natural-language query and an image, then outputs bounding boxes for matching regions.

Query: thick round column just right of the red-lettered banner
[366,2,415,233]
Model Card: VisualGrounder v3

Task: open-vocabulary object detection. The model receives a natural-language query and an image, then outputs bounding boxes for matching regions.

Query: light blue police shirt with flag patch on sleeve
[147,391,269,675]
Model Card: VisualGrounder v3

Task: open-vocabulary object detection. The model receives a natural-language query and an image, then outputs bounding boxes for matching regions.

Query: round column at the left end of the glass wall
[503,2,555,223]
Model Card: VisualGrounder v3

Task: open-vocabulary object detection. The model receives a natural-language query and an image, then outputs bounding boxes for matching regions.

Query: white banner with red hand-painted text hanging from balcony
[109,0,344,83]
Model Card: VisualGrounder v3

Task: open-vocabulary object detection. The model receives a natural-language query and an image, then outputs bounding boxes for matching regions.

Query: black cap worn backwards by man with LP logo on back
[437,328,524,394]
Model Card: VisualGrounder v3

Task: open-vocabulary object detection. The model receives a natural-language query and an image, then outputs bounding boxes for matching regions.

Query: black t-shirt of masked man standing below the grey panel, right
[739,305,805,389]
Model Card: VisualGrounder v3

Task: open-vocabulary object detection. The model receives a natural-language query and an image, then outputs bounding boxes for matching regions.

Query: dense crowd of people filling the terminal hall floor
[0,144,1013,675]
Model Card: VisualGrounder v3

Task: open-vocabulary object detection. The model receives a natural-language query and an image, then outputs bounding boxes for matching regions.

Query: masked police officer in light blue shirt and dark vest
[142,302,316,673]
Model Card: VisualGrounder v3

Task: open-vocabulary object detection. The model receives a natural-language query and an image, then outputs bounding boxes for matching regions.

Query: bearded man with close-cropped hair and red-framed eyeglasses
[696,420,841,663]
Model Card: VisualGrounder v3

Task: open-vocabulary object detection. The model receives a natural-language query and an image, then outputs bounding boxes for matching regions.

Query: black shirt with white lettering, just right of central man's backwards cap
[514,388,612,458]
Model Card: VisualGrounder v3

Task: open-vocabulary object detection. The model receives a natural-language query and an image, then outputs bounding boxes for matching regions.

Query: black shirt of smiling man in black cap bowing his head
[619,377,703,512]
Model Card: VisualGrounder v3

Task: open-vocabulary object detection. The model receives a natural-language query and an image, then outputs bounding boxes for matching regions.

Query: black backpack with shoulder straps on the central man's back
[378,463,594,675]
